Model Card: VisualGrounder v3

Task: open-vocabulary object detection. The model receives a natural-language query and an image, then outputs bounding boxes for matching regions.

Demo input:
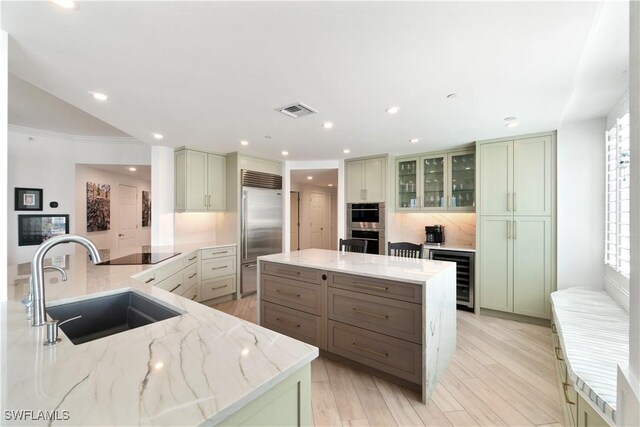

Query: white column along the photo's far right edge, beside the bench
[616,1,640,426]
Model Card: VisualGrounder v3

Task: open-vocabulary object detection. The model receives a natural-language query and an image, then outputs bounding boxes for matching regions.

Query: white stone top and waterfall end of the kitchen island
[258,249,456,402]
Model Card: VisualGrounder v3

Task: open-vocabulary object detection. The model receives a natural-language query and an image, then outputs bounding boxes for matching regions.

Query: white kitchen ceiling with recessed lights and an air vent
[2,1,628,160]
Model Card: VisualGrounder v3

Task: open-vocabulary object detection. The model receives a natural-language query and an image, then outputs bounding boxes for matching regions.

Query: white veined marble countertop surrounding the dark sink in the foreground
[0,243,318,425]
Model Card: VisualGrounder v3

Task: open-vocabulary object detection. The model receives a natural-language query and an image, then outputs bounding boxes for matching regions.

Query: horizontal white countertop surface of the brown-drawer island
[258,249,455,285]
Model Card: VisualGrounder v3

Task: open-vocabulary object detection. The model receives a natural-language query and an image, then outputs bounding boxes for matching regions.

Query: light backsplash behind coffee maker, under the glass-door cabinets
[387,212,476,246]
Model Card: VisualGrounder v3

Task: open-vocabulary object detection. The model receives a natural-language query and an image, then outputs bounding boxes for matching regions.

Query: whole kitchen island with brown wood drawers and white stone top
[258,249,456,402]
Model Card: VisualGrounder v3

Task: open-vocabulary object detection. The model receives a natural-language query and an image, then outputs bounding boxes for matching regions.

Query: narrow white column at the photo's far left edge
[0,24,7,302]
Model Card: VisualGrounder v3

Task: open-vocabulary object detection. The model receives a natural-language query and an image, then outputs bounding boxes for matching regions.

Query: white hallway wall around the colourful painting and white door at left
[75,164,153,251]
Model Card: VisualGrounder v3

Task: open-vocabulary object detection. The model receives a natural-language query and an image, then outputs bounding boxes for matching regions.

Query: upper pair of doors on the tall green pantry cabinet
[479,136,552,216]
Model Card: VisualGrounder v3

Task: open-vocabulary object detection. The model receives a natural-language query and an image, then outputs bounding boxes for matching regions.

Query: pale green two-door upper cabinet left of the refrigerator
[175,148,227,212]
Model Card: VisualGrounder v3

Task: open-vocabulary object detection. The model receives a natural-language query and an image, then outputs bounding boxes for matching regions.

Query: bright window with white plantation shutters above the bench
[605,112,631,278]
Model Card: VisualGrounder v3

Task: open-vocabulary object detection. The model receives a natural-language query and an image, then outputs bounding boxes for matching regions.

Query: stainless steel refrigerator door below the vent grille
[240,182,283,296]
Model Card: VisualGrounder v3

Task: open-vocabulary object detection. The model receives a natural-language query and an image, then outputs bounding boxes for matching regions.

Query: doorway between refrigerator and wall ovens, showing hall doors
[290,169,338,251]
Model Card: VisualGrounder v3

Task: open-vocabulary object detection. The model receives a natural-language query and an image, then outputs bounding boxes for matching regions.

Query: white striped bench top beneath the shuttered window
[551,288,629,423]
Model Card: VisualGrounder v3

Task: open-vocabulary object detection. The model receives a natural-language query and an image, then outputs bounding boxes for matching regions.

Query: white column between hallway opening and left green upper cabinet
[151,146,175,246]
